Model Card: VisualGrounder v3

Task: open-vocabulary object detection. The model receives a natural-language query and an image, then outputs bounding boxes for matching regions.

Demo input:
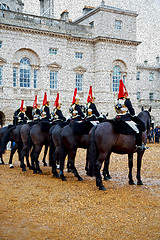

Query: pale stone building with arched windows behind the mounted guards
[0,0,160,125]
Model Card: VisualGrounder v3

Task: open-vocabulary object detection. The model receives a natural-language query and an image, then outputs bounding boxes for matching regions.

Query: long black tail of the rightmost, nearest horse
[87,126,98,177]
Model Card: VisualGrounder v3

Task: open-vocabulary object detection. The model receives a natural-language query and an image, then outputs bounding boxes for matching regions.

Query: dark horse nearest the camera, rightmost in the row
[88,108,151,190]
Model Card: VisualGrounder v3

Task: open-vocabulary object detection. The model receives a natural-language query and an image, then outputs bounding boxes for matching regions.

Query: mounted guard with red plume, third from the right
[69,88,85,121]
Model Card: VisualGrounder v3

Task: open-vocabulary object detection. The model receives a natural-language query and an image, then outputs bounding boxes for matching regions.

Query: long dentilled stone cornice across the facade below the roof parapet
[0,23,141,46]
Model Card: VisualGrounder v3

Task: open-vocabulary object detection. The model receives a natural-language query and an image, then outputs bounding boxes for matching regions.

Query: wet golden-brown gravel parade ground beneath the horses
[0,144,160,240]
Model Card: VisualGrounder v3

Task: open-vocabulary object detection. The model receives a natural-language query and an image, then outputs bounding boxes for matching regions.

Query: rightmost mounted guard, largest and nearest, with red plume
[115,79,147,150]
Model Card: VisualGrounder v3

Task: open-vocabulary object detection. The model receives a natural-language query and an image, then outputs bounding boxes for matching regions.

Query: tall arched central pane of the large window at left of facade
[20,58,31,87]
